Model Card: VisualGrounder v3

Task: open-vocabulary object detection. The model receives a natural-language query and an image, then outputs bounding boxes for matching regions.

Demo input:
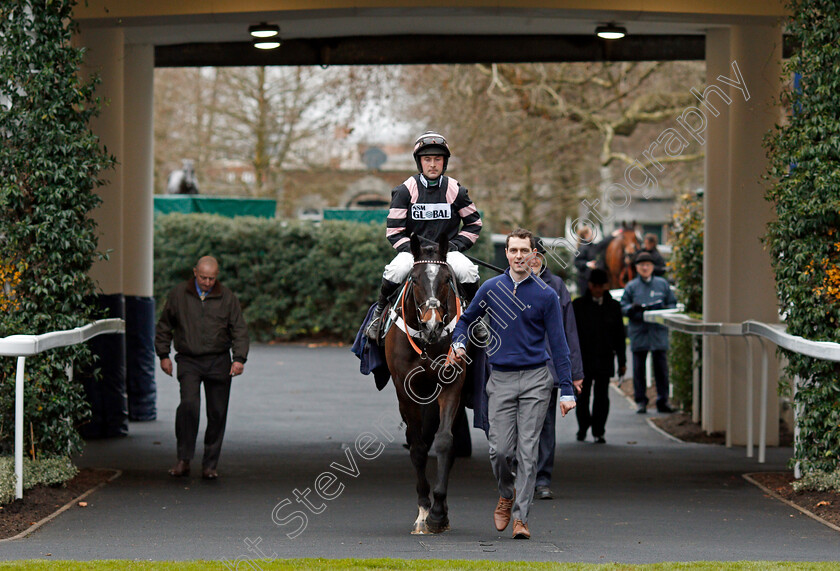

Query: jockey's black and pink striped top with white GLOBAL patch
[386,174,481,252]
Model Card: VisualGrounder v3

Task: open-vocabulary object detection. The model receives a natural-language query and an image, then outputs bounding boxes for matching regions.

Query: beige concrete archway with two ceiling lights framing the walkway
[76,0,785,444]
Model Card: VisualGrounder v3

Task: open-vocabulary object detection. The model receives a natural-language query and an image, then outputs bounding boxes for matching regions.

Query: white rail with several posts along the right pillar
[644,309,840,478]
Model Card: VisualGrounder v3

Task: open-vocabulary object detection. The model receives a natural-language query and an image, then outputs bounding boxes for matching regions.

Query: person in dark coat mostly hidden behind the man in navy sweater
[530,246,584,500]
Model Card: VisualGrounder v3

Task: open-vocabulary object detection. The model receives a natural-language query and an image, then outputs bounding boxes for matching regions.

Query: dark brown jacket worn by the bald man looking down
[155,279,248,363]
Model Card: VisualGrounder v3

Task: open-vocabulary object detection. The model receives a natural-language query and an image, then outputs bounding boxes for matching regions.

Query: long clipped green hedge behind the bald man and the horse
[155,214,491,342]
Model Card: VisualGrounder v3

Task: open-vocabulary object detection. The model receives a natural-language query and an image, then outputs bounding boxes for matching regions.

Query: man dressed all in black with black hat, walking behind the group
[572,269,627,444]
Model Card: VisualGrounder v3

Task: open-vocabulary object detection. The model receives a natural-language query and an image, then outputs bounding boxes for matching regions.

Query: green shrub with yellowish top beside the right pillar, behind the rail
[668,194,703,409]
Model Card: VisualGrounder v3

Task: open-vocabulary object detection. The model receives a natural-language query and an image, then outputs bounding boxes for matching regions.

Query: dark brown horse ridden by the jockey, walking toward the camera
[385,234,466,534]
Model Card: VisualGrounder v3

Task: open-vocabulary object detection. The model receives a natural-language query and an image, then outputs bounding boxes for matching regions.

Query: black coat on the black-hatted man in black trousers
[572,289,627,378]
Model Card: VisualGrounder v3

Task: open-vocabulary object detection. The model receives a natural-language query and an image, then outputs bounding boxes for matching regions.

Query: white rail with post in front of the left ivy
[0,319,125,499]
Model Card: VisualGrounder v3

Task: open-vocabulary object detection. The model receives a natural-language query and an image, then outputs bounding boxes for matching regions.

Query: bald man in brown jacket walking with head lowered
[155,256,248,480]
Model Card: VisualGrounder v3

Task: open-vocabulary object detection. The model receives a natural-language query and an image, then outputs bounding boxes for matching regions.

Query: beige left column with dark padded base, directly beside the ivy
[77,24,128,438]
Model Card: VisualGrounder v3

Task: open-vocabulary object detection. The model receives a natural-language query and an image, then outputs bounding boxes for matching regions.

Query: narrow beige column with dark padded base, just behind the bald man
[122,44,157,420]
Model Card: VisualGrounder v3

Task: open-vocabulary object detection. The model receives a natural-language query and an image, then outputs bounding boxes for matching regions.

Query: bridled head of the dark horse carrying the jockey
[404,234,457,344]
